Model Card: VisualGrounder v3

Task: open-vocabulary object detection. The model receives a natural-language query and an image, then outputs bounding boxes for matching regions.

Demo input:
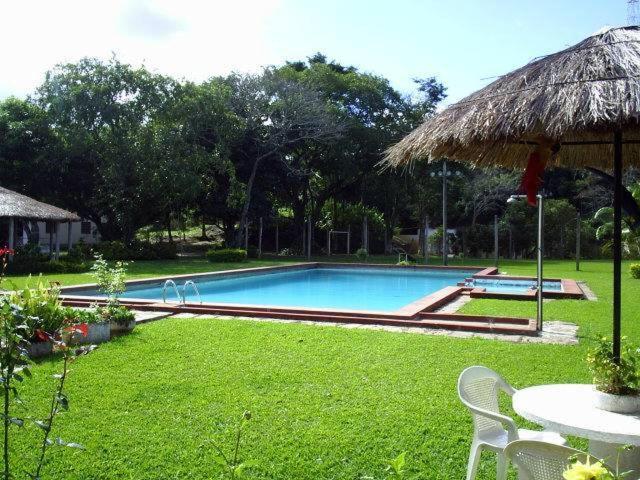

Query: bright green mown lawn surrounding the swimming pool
[6,260,640,480]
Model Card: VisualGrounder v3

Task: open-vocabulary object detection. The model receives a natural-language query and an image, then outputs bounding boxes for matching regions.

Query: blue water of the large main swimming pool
[84,268,475,312]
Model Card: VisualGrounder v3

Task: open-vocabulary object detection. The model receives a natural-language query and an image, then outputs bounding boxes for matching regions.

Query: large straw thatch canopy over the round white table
[384,27,640,168]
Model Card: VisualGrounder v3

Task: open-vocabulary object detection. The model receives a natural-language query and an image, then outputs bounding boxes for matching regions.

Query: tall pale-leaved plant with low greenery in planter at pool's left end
[91,254,136,334]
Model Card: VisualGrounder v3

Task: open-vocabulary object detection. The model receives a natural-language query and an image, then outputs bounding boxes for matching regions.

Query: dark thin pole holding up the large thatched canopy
[613,129,622,363]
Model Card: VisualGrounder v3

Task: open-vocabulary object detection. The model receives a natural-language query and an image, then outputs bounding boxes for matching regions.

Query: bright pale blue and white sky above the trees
[0,0,627,103]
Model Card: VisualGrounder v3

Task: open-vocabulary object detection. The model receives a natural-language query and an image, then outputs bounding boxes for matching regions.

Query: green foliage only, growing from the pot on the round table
[587,337,640,395]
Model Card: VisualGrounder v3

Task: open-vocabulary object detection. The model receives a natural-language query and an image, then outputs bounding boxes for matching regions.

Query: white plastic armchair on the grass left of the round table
[458,366,566,480]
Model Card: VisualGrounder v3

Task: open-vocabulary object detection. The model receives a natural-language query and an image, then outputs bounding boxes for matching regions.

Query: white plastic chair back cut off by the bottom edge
[504,440,597,480]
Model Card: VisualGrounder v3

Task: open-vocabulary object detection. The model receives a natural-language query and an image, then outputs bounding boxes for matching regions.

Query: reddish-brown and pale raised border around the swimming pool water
[60,262,584,336]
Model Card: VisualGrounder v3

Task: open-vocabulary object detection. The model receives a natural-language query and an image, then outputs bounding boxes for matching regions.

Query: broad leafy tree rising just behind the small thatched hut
[35,58,176,242]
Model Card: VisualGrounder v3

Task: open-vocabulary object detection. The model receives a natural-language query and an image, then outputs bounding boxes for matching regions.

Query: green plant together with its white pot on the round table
[587,337,640,413]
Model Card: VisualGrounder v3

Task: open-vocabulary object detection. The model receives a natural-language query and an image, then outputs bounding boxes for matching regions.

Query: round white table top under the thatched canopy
[513,384,640,446]
